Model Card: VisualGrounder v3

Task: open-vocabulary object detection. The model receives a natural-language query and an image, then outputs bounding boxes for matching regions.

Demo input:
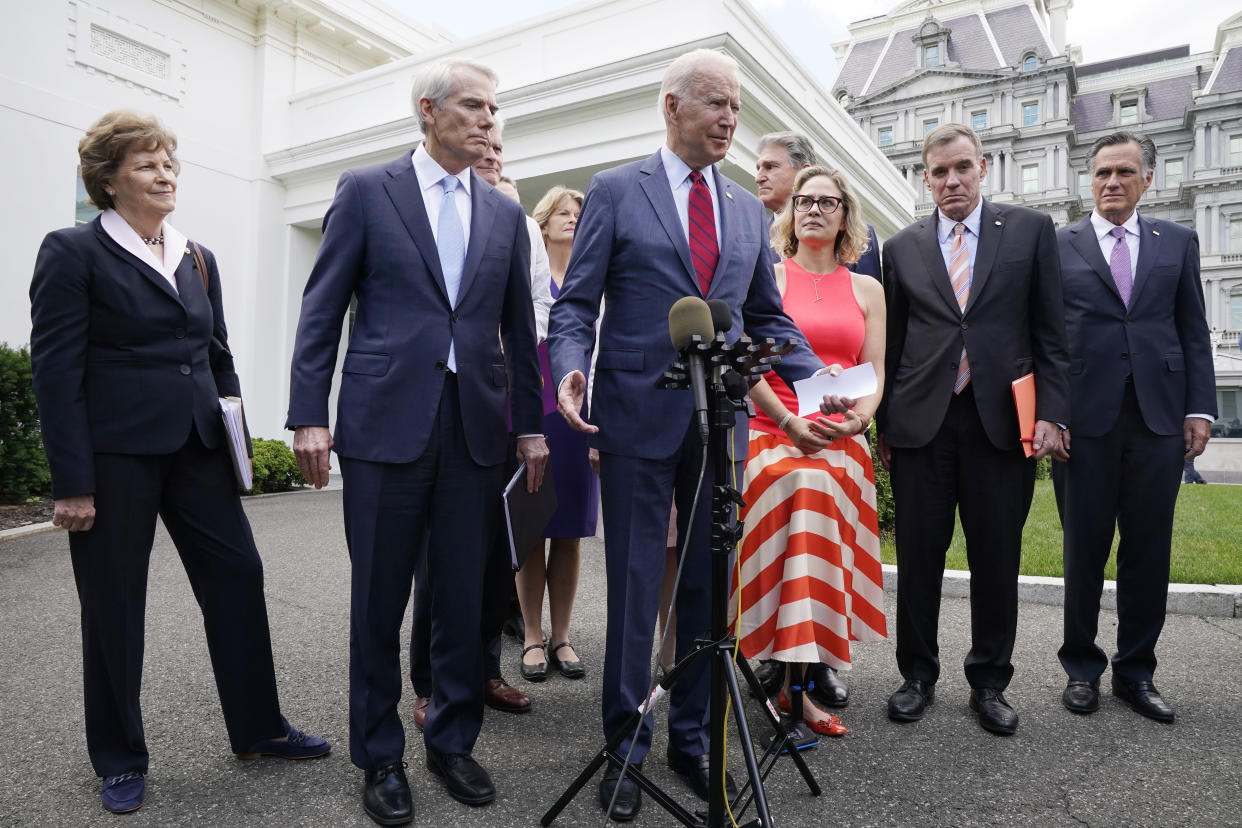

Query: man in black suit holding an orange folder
[877,124,1069,735]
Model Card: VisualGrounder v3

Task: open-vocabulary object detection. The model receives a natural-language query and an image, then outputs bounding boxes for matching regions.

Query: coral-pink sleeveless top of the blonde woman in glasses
[750,258,866,436]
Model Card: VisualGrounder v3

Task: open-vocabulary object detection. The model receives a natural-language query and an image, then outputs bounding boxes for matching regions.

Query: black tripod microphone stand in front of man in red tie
[539,333,821,828]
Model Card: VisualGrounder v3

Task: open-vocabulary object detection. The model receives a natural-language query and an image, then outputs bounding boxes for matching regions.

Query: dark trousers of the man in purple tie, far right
[1053,384,1185,682]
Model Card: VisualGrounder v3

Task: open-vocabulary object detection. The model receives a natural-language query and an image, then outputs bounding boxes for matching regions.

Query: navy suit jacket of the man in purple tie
[1057,214,1216,437]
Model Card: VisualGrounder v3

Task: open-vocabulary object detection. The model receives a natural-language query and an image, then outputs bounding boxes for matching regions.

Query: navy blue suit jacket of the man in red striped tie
[548,151,822,459]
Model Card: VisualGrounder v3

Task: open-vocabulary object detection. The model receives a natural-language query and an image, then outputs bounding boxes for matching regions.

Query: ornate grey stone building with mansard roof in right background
[832,0,1242,477]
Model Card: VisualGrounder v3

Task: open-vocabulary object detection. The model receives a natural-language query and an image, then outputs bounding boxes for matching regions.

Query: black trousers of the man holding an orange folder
[891,385,1035,690]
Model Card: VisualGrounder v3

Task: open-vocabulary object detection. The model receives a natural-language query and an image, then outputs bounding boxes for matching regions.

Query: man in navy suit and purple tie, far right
[1053,132,1216,722]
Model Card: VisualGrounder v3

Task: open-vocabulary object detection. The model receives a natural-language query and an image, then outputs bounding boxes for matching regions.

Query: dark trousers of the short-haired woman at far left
[70,430,284,776]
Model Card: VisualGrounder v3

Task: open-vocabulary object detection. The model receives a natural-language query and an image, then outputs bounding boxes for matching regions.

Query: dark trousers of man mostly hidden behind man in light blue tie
[410,433,520,698]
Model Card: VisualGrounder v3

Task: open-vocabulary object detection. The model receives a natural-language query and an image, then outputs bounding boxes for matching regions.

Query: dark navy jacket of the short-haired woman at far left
[30,217,241,498]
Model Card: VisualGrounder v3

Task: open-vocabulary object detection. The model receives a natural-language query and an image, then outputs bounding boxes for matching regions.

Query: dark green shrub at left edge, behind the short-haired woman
[0,343,52,503]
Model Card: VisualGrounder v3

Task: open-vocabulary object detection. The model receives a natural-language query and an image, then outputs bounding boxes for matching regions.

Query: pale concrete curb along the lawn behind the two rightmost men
[884,564,1242,618]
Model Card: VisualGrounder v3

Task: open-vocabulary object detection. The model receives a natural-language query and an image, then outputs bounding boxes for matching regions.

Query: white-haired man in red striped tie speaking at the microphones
[548,50,822,821]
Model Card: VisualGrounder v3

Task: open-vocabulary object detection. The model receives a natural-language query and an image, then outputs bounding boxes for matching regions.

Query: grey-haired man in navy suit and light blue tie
[287,61,548,824]
